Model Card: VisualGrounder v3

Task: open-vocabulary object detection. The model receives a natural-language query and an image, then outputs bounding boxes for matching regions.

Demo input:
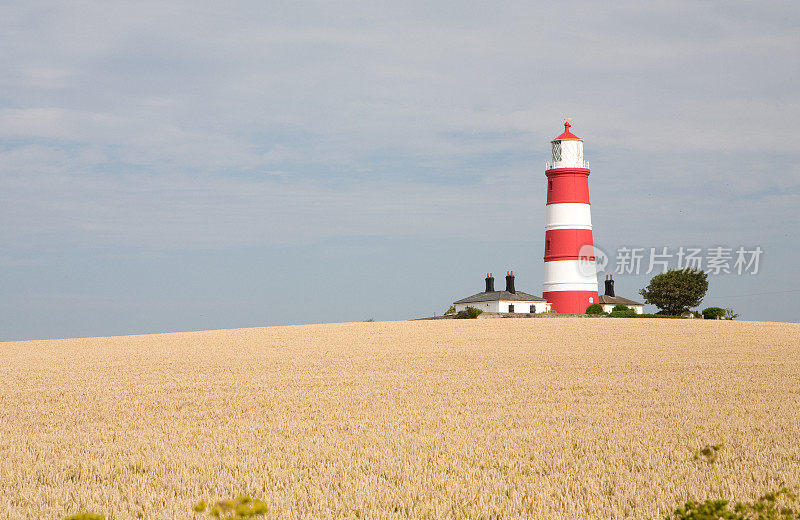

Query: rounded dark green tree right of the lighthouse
[639,269,708,315]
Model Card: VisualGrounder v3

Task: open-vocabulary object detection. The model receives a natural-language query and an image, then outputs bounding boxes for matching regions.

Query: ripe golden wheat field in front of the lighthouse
[0,319,800,520]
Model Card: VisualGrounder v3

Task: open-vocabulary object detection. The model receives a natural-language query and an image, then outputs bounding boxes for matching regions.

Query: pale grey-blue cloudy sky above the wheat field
[0,0,800,340]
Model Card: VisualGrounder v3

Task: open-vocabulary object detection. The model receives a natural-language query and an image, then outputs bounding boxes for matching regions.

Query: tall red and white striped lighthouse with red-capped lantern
[542,121,597,314]
